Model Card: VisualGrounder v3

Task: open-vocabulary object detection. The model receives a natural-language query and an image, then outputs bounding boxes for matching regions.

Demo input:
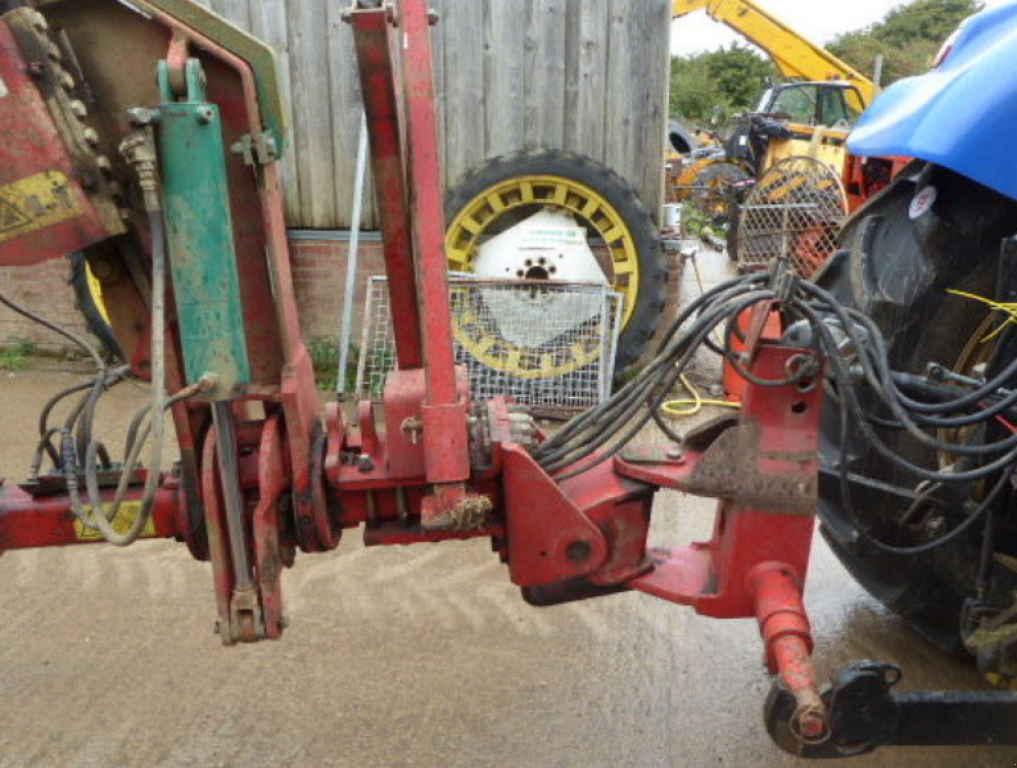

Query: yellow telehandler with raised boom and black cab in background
[671,0,878,214]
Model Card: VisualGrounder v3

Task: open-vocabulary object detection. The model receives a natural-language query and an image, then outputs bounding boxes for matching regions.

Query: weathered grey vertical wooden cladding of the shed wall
[191,0,670,229]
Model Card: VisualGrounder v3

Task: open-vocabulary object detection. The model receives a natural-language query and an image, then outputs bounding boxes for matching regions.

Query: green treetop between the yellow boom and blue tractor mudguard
[828,0,982,85]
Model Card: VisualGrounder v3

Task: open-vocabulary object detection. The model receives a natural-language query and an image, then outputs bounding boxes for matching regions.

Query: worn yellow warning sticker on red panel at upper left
[0,171,81,243]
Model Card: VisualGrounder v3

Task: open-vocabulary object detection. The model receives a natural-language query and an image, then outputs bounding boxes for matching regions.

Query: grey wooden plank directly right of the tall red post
[442,0,484,184]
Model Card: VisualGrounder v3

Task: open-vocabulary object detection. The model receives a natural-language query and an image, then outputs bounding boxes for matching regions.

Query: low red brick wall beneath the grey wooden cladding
[0,239,681,360]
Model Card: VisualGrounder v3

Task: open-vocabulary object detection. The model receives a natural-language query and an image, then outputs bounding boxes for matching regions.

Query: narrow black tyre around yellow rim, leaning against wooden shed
[444,150,667,373]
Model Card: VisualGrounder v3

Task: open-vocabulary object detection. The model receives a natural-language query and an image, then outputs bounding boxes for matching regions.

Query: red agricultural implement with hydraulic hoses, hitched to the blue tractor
[0,0,1017,757]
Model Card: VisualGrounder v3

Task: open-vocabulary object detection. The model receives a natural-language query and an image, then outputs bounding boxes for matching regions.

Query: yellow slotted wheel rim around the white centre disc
[445,175,640,379]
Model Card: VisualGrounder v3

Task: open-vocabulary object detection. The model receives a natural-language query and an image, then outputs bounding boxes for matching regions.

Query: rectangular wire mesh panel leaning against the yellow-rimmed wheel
[357,276,622,409]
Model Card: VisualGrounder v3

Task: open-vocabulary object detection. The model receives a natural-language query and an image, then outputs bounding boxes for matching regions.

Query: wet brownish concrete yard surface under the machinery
[0,249,1017,768]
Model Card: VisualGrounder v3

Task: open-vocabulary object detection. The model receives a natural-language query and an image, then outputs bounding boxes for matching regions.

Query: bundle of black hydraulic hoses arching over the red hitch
[533,267,1017,555]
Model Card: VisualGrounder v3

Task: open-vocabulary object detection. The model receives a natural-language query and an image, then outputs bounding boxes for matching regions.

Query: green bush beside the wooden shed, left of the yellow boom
[671,44,777,123]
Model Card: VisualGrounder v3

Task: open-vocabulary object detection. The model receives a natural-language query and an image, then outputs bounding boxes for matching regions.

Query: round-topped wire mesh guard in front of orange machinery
[734,157,847,278]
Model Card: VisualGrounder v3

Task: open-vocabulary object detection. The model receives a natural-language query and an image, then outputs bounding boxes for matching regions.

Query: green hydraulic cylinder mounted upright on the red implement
[157,59,250,400]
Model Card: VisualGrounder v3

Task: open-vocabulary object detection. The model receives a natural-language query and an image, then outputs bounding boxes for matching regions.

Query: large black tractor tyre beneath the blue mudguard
[815,165,1017,653]
